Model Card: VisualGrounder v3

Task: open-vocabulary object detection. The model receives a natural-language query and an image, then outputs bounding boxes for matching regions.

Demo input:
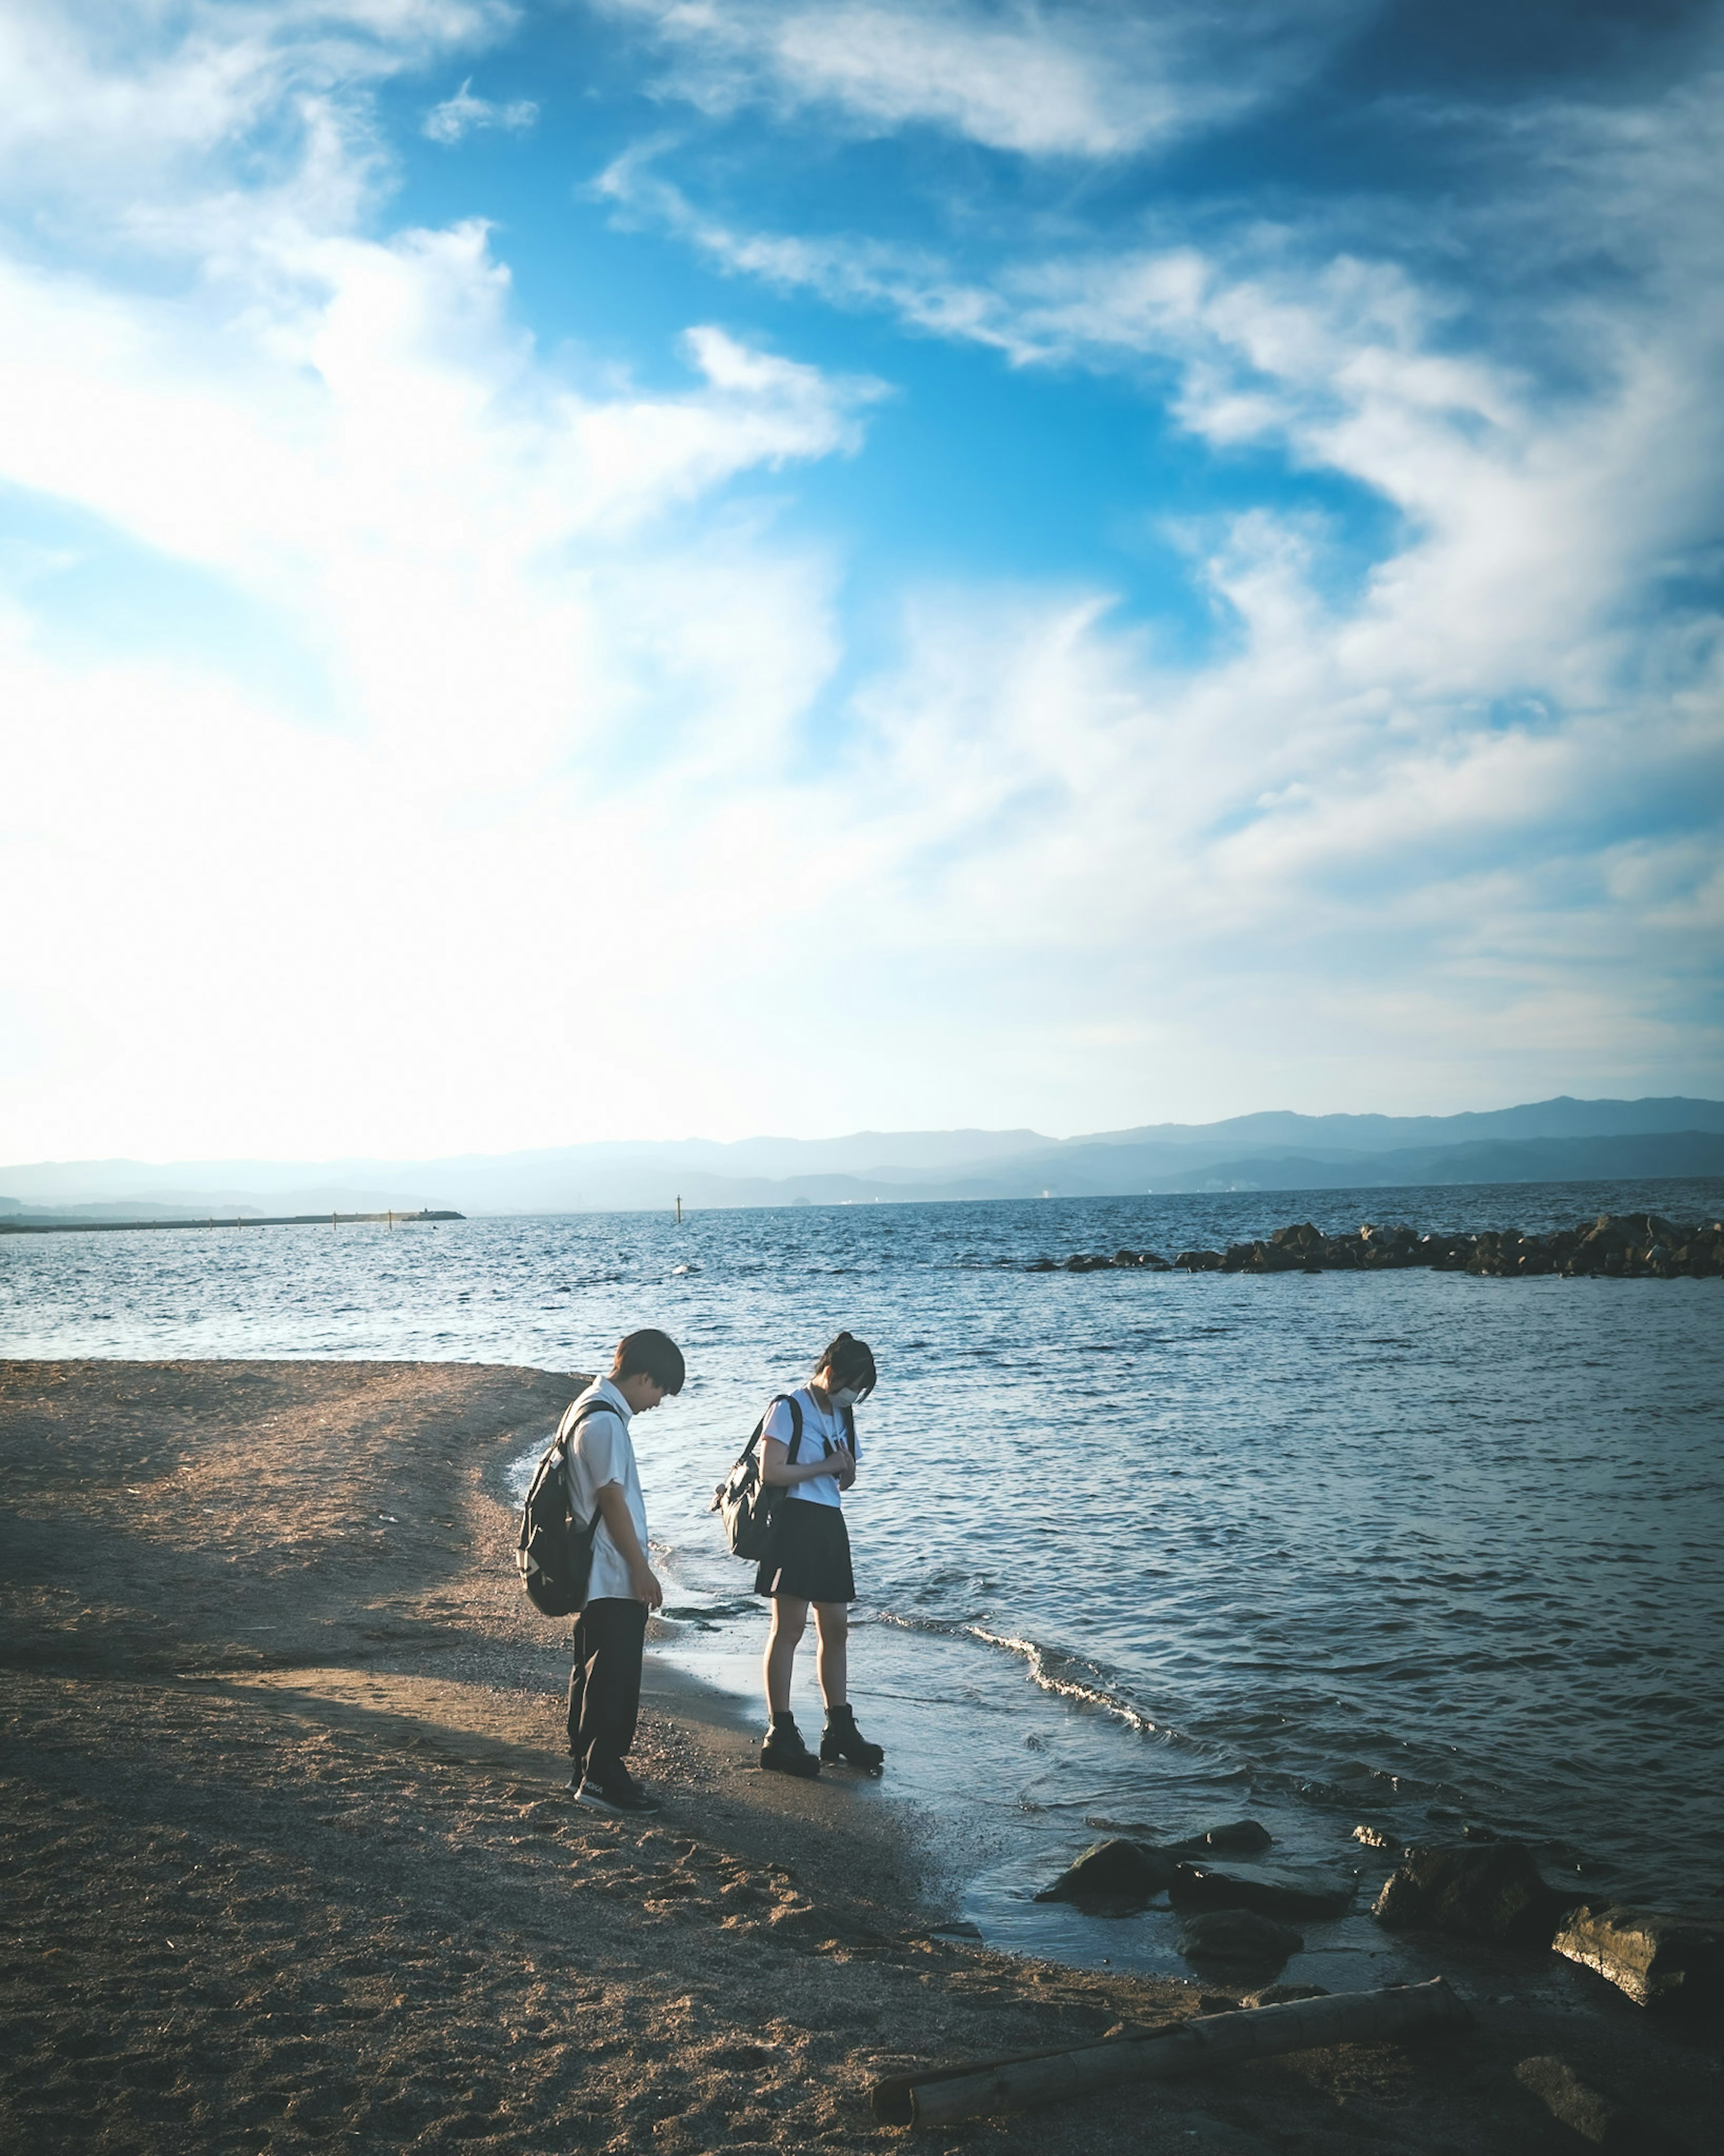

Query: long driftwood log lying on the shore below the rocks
[871,1977,1472,2126]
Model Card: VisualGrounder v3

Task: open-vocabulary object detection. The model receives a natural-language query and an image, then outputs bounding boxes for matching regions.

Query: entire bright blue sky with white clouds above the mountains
[0,0,1724,1160]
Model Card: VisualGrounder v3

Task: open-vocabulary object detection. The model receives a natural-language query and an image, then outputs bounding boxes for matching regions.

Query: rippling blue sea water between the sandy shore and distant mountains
[0,1184,1724,1981]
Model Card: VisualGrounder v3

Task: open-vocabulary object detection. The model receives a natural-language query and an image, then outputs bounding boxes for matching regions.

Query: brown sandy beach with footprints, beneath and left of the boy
[0,1362,1720,2156]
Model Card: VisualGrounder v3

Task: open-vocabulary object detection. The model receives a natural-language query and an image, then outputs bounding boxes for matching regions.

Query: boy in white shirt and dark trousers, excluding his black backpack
[569,1328,683,1813]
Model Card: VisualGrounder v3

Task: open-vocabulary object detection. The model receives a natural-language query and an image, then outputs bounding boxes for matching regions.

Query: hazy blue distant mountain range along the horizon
[0,1095,1724,1222]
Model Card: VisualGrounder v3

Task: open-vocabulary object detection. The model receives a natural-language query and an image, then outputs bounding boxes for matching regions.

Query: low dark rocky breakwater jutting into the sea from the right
[1026,1214,1724,1281]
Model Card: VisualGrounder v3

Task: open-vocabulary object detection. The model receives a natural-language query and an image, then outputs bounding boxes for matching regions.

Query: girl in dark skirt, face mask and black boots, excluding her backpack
[754,1332,886,1774]
